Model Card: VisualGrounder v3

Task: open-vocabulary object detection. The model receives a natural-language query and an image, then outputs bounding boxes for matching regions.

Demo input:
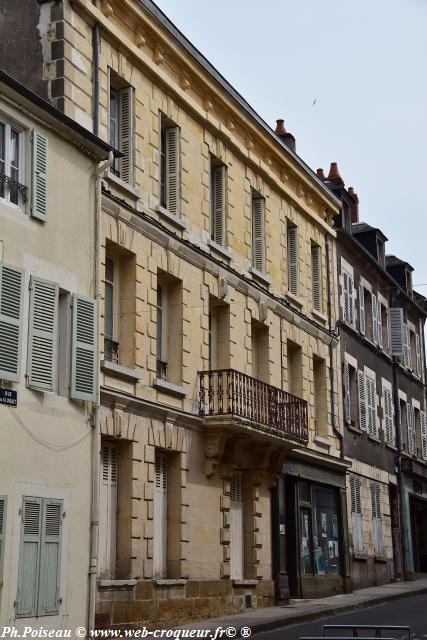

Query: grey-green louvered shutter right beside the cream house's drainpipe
[70,294,98,402]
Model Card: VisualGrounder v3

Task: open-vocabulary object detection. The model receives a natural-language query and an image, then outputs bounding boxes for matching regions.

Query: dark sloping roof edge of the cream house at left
[0,69,115,160]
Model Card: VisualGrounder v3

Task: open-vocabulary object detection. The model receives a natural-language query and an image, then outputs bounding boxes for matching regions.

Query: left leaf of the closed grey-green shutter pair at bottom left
[16,497,43,618]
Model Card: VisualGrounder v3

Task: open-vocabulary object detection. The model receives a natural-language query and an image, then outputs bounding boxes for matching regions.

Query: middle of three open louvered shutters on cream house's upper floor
[27,277,59,391]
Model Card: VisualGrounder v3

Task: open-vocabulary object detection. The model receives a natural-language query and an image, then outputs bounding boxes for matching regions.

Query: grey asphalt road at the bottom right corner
[255,594,427,640]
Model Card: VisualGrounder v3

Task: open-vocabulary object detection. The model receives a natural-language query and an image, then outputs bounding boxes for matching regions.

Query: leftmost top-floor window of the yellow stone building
[108,76,134,184]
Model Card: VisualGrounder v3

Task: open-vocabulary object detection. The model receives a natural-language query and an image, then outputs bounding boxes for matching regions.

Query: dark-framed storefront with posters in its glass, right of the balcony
[275,459,349,598]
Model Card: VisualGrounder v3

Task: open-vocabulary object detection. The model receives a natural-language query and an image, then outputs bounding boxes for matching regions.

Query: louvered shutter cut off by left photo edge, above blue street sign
[0,262,24,382]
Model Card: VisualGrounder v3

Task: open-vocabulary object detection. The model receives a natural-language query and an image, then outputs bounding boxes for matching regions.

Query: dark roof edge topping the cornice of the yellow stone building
[139,0,341,205]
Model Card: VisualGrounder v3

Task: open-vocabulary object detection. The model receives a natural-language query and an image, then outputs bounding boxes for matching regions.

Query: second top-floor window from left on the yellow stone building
[160,115,180,215]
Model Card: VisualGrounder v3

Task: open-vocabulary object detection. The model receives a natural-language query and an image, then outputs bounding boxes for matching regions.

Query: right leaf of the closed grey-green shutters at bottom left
[37,498,63,616]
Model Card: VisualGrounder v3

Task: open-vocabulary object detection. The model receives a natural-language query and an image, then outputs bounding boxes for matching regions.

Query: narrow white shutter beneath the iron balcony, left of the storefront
[230,471,244,580]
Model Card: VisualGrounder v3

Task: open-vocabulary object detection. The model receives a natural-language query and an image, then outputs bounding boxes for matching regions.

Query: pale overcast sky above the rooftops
[157,0,427,296]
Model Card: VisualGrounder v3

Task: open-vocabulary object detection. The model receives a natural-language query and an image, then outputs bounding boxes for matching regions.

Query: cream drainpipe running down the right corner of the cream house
[88,151,114,632]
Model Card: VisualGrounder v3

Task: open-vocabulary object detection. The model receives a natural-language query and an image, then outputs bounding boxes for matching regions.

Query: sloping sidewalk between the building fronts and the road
[179,578,427,637]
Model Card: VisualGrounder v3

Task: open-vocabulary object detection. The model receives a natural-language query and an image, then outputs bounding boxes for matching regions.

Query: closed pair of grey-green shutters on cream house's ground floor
[15,496,64,618]
